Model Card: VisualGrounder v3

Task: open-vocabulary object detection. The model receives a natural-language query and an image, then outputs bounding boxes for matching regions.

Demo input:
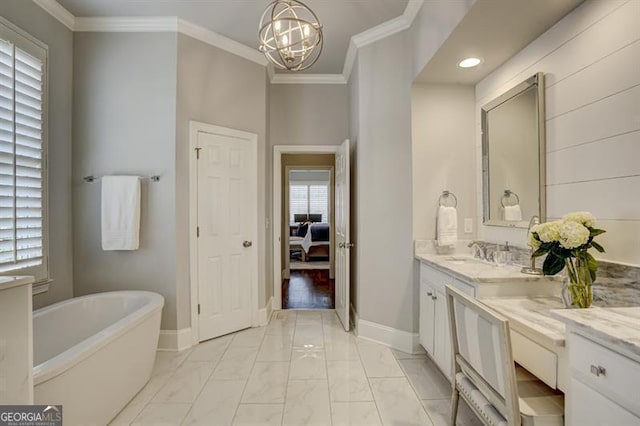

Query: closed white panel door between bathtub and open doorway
[197,131,257,341]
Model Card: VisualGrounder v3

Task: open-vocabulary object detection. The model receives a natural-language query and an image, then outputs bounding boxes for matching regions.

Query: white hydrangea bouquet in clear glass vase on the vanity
[528,212,606,308]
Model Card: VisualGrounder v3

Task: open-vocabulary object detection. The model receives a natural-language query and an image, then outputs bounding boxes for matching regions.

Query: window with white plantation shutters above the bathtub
[0,22,48,281]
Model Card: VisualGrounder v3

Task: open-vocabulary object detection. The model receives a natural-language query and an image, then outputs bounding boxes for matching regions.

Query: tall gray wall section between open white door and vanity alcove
[356,31,418,331]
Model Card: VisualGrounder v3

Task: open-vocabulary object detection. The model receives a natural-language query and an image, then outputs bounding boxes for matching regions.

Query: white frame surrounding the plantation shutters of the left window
[0,16,52,282]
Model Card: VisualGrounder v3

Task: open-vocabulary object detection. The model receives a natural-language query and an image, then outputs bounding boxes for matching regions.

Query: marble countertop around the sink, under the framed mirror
[415,253,560,283]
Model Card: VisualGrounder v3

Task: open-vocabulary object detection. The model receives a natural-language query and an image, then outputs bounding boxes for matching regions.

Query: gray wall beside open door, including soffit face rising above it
[349,0,473,332]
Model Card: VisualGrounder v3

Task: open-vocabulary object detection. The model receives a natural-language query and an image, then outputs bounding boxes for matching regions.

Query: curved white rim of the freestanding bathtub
[33,290,164,386]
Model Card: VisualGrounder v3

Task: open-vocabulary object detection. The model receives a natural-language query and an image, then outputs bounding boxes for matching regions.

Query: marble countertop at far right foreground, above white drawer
[550,307,640,360]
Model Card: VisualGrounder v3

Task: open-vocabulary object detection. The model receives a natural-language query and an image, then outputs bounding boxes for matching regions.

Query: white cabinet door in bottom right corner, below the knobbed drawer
[565,378,640,426]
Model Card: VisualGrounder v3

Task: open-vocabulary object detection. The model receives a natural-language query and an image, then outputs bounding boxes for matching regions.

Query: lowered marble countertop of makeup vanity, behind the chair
[480,297,565,347]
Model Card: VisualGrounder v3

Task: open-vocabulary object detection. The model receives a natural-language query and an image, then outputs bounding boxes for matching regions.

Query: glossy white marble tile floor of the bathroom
[111,310,481,426]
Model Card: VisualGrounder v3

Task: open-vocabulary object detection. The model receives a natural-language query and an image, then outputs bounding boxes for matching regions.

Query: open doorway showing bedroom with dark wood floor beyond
[280,154,335,309]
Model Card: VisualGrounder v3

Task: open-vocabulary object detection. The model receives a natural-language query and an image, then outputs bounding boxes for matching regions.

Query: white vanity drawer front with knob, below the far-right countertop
[568,333,640,416]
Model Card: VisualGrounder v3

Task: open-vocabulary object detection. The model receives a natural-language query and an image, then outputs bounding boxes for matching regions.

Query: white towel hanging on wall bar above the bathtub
[102,176,140,250]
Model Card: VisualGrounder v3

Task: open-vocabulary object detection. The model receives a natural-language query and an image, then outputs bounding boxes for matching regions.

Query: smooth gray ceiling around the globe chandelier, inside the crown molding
[53,0,408,74]
